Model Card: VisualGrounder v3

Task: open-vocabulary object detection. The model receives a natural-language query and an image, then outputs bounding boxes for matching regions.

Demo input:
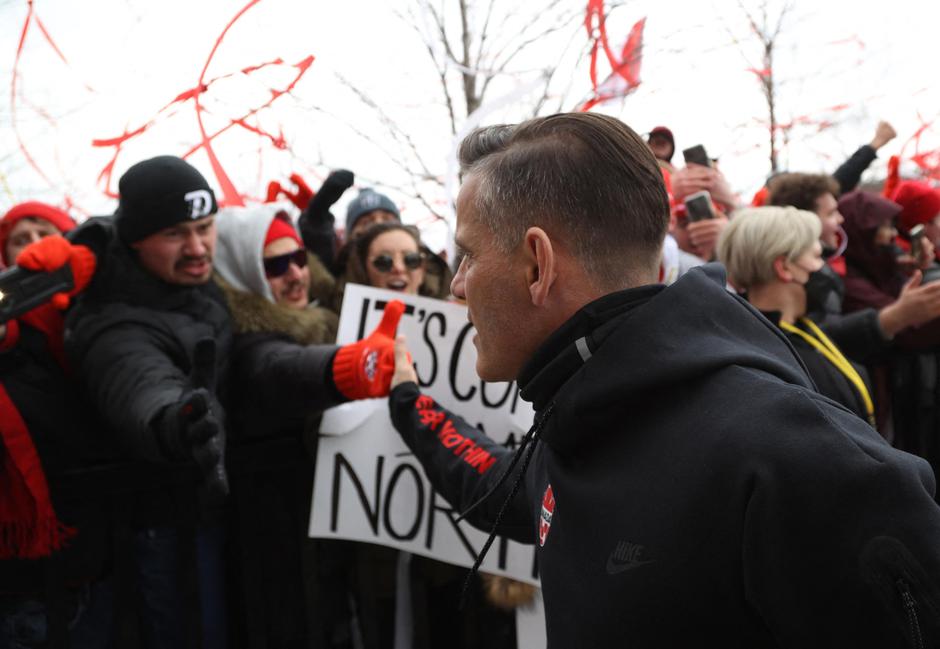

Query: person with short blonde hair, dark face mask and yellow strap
[718,207,875,426]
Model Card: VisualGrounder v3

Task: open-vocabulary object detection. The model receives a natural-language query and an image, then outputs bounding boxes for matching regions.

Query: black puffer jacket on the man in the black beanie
[65,223,232,461]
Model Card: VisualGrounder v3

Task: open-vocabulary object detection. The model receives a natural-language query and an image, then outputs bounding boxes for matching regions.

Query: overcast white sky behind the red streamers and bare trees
[0,0,940,251]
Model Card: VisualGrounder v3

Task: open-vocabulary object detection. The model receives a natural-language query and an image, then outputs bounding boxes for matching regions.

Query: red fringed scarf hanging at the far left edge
[0,307,75,559]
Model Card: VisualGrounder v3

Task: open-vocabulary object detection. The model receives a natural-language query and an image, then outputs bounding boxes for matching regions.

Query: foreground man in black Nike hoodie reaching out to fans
[390,114,940,649]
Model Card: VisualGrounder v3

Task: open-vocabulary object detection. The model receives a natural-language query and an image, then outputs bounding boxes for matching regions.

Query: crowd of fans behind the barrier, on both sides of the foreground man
[0,114,940,649]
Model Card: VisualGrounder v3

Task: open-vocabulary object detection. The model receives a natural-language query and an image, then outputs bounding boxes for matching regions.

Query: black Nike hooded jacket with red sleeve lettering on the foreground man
[391,269,940,649]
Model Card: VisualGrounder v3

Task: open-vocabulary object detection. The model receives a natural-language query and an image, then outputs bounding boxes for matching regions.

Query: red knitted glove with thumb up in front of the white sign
[333,300,405,399]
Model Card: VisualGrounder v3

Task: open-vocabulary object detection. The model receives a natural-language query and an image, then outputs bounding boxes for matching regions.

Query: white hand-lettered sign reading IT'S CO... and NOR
[310,284,538,585]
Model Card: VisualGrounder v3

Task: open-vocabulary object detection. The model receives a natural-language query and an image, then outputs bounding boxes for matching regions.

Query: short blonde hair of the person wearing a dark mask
[718,206,822,289]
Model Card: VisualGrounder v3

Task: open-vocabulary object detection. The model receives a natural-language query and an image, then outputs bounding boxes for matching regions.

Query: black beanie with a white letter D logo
[114,155,219,244]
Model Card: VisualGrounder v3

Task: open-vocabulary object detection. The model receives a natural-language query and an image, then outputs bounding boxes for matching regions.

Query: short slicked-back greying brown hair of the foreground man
[460,113,669,289]
